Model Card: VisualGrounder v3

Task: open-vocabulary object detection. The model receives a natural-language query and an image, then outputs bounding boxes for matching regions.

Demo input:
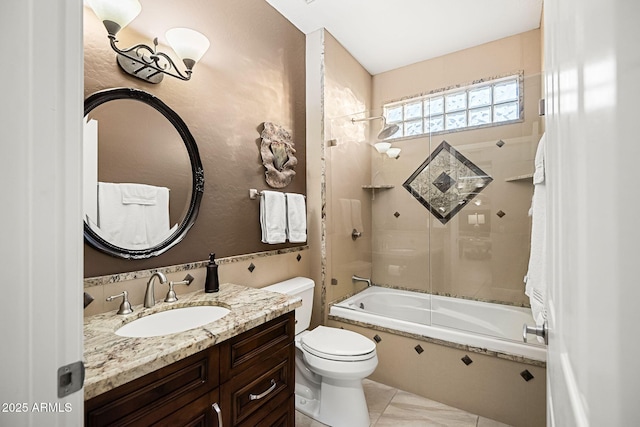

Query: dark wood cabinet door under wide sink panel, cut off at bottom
[152,389,222,427]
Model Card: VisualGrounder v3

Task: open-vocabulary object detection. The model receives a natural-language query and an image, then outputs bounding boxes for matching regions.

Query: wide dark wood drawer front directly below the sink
[85,347,220,426]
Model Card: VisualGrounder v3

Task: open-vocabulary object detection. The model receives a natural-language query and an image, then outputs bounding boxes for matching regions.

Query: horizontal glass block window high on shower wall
[383,73,523,139]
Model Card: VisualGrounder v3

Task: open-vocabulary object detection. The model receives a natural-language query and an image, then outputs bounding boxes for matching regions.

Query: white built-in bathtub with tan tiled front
[329,286,546,361]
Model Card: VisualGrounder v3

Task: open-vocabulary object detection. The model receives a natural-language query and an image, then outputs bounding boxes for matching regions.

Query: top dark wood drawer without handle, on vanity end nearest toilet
[220,311,295,382]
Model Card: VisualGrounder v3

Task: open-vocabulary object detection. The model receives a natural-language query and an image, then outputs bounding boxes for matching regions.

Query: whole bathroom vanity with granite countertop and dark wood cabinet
[85,284,300,427]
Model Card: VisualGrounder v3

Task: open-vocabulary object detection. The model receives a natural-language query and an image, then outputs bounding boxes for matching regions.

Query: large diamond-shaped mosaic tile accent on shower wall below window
[402,141,493,224]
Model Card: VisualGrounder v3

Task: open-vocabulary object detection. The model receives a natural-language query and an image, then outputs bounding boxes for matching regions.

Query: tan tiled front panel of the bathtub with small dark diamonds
[329,320,546,427]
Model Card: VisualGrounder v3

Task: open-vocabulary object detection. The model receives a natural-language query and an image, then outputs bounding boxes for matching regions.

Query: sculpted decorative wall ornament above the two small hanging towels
[260,122,298,188]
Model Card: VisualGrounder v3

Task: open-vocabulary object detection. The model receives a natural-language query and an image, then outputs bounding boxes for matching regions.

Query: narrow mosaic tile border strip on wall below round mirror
[84,245,309,289]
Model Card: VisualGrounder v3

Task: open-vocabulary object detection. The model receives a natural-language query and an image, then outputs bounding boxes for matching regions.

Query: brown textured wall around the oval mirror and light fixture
[84,0,306,277]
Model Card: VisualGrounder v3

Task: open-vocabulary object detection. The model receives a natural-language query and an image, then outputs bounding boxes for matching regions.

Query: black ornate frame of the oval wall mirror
[84,88,204,259]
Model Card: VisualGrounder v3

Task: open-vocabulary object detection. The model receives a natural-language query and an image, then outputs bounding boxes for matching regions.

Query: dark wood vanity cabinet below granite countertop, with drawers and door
[85,312,295,427]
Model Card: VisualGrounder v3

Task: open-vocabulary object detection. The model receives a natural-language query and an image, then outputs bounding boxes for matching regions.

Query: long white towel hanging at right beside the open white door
[525,135,547,334]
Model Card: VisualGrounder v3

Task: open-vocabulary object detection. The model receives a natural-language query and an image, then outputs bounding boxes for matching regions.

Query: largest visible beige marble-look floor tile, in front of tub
[375,390,478,427]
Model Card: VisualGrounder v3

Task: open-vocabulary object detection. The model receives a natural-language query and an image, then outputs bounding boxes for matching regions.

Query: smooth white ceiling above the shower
[266,0,543,75]
